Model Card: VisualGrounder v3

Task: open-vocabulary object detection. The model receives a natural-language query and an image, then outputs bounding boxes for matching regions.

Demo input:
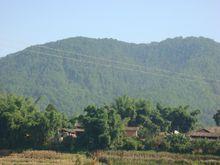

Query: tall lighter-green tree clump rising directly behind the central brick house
[113,96,170,137]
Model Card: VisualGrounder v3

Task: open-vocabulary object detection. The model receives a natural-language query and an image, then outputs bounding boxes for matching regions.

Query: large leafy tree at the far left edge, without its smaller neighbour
[0,94,44,148]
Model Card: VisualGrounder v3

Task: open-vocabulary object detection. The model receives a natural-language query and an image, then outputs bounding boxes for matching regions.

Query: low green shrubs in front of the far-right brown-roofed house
[143,134,220,155]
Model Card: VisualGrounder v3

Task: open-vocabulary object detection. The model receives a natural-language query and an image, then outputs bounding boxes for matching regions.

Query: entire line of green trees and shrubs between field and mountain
[0,94,220,154]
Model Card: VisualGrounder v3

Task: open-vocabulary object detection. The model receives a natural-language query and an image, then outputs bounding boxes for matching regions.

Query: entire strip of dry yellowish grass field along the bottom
[0,150,220,165]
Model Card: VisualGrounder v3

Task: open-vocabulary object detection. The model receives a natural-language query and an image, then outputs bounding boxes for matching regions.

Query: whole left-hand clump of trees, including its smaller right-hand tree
[0,95,67,148]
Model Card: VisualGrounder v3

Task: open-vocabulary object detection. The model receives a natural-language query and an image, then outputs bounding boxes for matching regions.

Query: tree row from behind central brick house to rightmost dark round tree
[112,96,199,133]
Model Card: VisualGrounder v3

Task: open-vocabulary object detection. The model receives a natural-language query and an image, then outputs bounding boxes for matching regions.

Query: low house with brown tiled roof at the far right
[187,127,220,140]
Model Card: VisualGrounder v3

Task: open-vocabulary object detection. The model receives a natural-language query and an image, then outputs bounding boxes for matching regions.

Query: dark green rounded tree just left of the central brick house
[78,106,123,150]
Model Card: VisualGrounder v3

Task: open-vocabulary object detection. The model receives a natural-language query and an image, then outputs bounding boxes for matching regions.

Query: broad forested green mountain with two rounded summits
[0,37,220,124]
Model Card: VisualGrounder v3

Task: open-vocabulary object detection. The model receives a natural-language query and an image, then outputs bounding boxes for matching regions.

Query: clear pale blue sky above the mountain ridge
[0,0,220,57]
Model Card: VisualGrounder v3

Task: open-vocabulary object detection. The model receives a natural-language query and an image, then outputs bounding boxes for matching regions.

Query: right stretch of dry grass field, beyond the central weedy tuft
[96,151,220,165]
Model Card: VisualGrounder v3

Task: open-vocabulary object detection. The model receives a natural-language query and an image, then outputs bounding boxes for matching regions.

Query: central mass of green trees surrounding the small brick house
[70,96,198,150]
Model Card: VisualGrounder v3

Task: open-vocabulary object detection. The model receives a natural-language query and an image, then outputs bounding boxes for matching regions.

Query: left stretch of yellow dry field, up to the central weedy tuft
[0,151,97,165]
